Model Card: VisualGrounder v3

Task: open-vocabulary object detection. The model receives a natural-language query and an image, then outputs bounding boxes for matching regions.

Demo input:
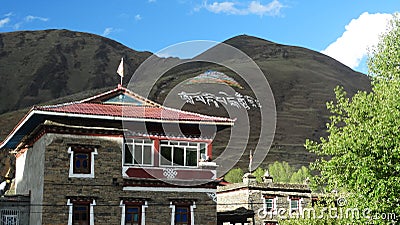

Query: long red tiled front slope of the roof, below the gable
[35,103,233,123]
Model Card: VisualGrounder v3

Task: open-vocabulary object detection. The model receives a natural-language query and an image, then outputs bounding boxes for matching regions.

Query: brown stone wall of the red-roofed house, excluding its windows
[42,134,217,225]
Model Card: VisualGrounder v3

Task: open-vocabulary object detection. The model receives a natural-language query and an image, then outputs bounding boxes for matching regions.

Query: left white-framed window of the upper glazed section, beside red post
[124,139,153,166]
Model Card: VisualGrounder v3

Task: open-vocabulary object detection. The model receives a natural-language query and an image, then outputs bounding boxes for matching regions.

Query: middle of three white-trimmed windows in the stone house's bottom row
[120,200,147,225]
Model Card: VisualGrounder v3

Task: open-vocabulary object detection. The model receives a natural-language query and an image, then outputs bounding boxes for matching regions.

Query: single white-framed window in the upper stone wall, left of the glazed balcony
[68,145,97,178]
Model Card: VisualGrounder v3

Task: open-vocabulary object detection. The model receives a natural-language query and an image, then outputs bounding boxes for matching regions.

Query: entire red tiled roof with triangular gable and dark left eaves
[0,86,235,149]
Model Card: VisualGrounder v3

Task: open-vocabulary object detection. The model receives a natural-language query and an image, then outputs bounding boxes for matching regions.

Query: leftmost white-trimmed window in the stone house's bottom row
[67,199,96,225]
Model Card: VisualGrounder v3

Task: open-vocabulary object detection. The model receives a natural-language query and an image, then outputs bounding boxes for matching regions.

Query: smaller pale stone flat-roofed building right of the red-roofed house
[217,173,312,225]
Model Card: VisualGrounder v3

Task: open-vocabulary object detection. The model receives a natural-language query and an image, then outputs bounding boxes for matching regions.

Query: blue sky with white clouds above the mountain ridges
[0,0,400,72]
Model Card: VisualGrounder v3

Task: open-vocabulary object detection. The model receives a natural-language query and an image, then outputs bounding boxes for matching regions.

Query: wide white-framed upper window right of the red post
[160,140,207,167]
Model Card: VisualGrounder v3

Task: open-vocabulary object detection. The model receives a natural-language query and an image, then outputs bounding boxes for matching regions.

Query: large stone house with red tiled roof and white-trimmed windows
[1,86,234,225]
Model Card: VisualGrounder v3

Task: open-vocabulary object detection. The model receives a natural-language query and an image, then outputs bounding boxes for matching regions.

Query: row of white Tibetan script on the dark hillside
[178,91,261,110]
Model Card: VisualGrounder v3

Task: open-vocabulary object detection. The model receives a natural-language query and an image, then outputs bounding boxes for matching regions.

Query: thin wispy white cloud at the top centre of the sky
[202,0,284,16]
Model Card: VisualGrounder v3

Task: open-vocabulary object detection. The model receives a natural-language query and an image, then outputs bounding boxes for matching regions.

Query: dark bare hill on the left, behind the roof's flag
[0,30,151,113]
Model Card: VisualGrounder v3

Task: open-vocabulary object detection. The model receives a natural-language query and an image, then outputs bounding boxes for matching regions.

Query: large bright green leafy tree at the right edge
[305,15,400,224]
